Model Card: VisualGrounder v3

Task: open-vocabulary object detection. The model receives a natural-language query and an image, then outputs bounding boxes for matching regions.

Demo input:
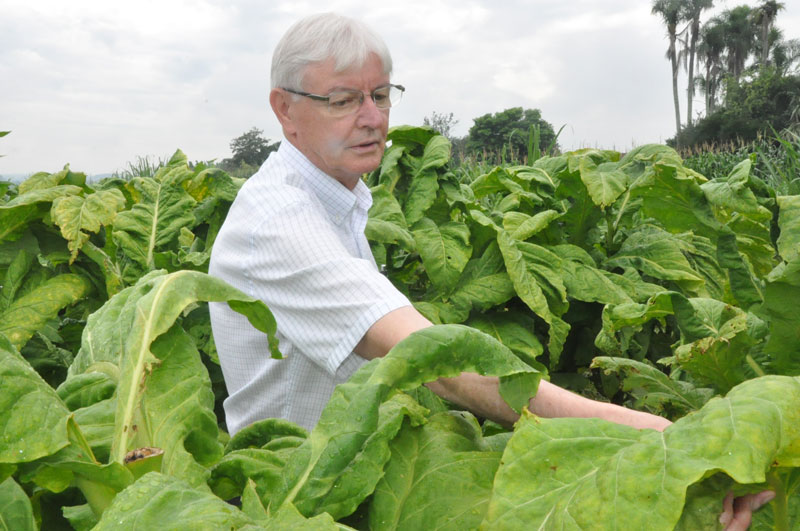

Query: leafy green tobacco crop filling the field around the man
[0,127,800,531]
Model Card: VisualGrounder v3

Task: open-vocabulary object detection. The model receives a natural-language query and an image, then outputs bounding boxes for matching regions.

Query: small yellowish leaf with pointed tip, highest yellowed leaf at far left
[50,188,125,262]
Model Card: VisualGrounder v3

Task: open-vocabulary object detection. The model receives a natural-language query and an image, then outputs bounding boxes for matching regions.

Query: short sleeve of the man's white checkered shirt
[244,198,410,374]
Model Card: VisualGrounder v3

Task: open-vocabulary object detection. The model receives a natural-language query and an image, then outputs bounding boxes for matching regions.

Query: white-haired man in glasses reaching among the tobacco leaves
[210,14,772,529]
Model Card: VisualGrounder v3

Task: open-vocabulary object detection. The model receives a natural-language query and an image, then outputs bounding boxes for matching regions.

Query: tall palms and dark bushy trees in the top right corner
[652,0,800,150]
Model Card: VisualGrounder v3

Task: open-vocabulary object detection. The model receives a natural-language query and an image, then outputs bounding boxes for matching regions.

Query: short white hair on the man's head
[270,13,392,90]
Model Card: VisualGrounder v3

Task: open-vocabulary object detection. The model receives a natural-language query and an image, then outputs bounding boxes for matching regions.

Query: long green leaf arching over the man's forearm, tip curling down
[270,325,540,519]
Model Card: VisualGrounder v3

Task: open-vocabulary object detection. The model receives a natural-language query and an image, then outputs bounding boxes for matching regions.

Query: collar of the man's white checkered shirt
[278,139,372,224]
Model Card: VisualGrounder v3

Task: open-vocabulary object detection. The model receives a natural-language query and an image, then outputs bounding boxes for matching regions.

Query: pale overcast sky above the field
[0,0,800,175]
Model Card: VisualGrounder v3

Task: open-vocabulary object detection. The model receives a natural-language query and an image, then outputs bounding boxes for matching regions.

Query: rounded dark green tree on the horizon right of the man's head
[466,107,558,160]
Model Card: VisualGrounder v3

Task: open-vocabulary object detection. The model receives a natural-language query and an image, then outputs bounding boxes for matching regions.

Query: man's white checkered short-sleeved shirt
[209,140,410,434]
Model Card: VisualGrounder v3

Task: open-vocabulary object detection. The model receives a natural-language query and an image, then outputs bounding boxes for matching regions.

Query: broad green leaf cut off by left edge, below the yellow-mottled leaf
[0,336,70,463]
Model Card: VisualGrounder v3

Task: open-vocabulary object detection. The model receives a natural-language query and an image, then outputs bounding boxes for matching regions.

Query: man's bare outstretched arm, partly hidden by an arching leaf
[355,306,671,431]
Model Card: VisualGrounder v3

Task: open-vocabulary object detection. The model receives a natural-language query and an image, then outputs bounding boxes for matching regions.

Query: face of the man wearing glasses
[283,54,389,189]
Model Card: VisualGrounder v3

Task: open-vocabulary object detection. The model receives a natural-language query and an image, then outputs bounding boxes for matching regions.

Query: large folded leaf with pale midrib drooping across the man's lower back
[69,271,280,484]
